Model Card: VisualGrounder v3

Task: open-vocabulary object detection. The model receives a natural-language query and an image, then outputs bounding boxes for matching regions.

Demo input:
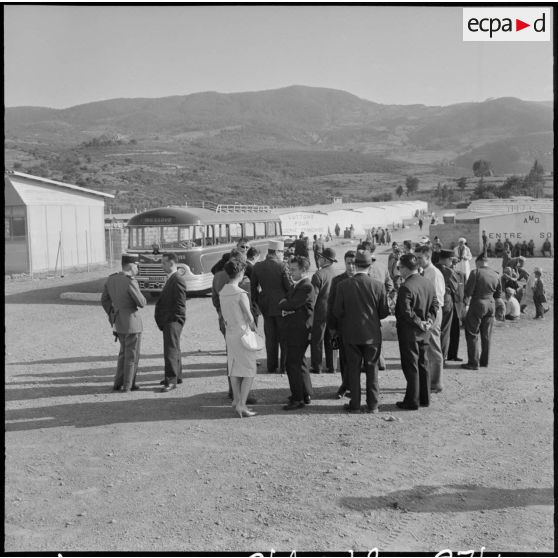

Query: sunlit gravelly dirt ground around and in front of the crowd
[4,232,554,555]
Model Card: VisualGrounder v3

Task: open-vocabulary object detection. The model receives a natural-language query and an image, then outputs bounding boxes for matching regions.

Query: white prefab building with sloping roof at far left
[4,171,114,274]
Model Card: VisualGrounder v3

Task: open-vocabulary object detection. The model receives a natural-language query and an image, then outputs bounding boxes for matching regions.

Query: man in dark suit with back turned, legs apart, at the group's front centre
[333,251,389,413]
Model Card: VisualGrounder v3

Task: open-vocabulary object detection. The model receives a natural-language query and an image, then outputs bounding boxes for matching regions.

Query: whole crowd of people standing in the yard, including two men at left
[102,230,548,417]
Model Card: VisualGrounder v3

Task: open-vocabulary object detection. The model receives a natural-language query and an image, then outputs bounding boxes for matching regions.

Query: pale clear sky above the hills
[4,4,554,108]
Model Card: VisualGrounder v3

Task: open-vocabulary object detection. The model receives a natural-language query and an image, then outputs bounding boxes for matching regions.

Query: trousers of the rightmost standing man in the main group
[464,299,494,366]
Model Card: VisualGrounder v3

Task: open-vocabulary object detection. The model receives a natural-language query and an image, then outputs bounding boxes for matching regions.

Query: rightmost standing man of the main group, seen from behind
[461,253,502,370]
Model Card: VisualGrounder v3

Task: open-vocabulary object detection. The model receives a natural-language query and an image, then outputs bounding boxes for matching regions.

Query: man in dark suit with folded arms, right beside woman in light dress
[279,256,314,411]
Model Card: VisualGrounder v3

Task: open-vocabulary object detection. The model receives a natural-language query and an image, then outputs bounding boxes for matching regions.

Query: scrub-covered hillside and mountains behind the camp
[5,86,553,210]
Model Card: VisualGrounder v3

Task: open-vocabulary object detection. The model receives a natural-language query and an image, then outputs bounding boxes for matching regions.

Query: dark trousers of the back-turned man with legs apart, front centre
[344,343,381,409]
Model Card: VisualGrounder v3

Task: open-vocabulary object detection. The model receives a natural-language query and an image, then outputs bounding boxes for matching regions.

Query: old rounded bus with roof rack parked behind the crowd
[126,202,282,296]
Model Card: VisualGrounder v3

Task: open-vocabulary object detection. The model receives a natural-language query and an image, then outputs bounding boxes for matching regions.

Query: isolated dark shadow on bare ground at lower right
[339,484,554,513]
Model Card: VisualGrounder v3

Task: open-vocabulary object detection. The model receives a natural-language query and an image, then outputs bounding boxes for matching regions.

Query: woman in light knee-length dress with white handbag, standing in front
[219,258,257,417]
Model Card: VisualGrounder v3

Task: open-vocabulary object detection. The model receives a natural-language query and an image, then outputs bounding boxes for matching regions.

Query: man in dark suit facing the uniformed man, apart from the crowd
[155,252,186,392]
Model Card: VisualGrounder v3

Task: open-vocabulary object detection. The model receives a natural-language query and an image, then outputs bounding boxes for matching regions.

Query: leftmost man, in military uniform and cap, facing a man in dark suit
[101,254,147,392]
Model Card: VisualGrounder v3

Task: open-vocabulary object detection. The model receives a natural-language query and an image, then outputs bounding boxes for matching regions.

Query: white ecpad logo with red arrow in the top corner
[463,6,552,41]
